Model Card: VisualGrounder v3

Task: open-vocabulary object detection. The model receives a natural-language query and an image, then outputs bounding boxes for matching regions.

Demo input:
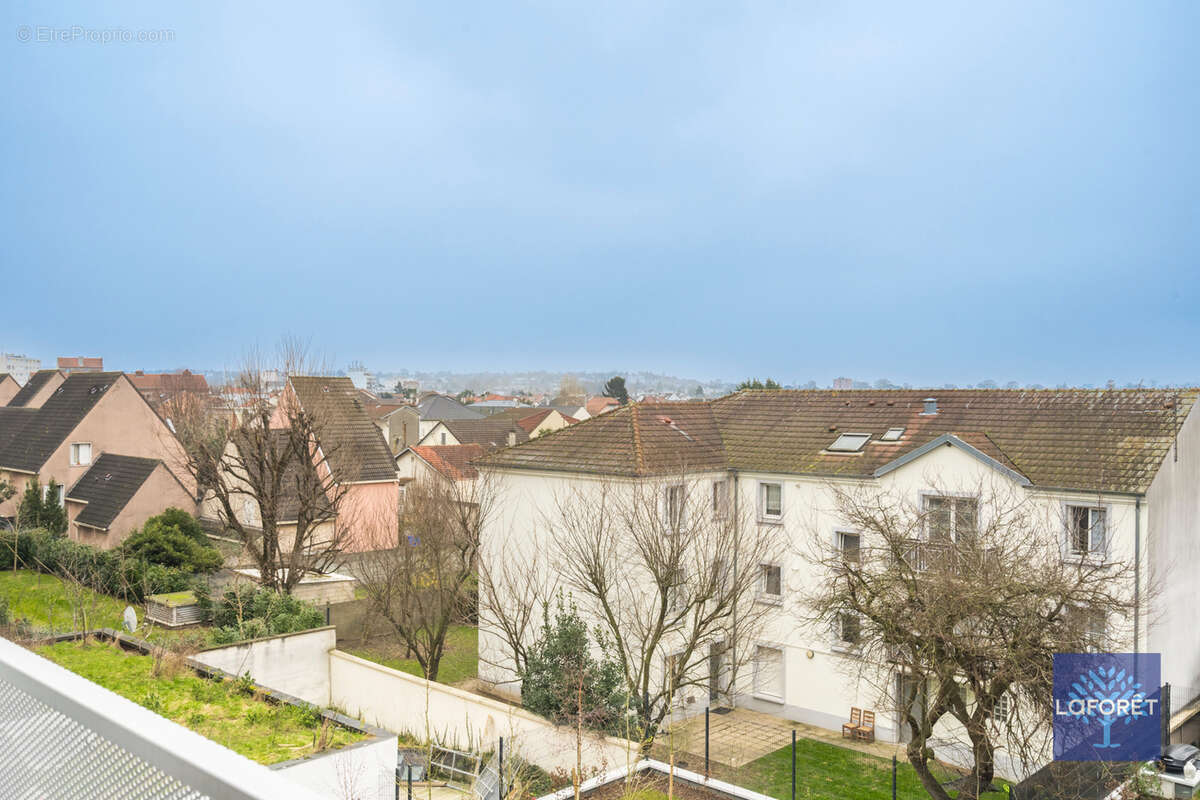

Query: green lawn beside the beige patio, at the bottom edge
[718,739,1007,800]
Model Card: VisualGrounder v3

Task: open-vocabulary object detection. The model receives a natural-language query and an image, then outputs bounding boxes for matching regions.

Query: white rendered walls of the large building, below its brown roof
[479,431,1200,775]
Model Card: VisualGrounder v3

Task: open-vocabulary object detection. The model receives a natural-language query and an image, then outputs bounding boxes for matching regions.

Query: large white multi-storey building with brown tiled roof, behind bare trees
[476,390,1200,766]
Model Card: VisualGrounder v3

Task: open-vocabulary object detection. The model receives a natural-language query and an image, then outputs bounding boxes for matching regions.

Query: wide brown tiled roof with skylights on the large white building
[487,389,1198,492]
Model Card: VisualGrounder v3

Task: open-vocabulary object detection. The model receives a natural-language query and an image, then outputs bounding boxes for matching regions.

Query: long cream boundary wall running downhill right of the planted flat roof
[329,650,638,771]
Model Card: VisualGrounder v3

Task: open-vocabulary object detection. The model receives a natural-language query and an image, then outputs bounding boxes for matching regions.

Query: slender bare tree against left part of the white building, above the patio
[546,473,779,752]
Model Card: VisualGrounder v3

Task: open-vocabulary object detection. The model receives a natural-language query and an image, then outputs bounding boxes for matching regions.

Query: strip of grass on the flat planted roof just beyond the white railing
[36,642,362,764]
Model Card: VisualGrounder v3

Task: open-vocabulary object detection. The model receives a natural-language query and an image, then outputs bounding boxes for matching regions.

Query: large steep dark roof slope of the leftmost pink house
[0,372,121,473]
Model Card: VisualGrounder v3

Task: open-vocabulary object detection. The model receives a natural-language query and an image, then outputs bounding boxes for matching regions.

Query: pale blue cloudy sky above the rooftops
[0,0,1200,384]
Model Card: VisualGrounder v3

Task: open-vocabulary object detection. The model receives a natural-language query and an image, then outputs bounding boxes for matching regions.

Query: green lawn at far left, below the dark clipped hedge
[0,570,210,646]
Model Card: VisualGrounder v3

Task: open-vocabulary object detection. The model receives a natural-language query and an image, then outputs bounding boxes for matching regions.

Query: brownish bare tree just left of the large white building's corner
[359,476,493,680]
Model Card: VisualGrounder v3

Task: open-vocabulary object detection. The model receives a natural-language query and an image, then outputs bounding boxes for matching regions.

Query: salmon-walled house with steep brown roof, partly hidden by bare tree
[271,375,400,552]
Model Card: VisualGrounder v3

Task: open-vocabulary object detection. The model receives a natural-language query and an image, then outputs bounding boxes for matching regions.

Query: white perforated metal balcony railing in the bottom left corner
[0,638,319,800]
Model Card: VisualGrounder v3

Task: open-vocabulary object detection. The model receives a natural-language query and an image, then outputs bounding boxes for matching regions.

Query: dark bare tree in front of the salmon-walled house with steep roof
[173,341,358,593]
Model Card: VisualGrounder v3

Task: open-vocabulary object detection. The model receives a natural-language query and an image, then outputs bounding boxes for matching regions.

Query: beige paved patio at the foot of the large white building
[656,709,902,768]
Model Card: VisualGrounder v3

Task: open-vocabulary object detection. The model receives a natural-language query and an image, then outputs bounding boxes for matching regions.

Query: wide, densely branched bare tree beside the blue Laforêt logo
[805,483,1135,800]
